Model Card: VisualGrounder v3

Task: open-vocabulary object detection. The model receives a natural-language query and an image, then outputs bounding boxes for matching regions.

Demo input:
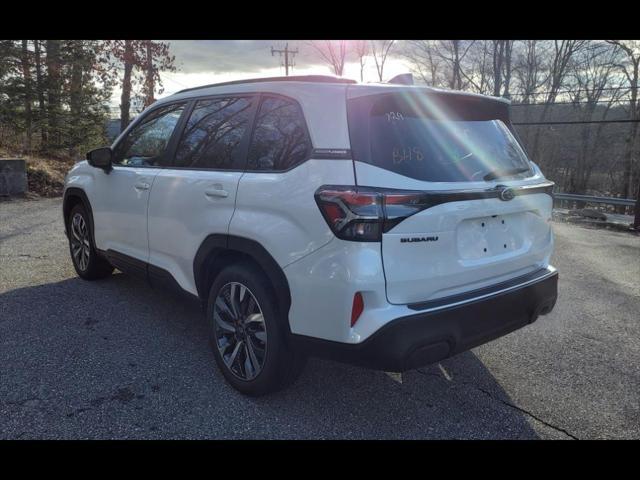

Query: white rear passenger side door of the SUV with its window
[148,95,257,294]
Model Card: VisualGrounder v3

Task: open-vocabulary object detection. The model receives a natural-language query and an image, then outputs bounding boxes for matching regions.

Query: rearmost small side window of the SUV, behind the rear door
[247,97,311,170]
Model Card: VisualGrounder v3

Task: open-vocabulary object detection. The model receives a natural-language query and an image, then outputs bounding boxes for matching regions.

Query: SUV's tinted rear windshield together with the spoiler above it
[348,94,532,182]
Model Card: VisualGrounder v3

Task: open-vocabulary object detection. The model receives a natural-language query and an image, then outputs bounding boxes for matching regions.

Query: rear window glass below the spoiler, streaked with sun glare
[349,94,532,182]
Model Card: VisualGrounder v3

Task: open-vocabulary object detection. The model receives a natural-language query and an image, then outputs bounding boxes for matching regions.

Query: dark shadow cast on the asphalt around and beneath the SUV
[0,273,538,438]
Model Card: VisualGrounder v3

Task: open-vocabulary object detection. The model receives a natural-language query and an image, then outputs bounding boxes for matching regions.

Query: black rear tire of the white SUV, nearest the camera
[207,263,305,396]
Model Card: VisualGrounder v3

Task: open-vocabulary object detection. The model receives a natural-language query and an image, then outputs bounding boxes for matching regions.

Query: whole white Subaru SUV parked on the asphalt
[63,76,557,395]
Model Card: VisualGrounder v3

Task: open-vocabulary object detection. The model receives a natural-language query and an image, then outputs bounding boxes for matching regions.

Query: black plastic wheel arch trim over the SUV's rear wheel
[193,234,291,332]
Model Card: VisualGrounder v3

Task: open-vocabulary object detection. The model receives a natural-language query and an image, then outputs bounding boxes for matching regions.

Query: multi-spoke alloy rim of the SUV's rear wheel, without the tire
[213,282,267,380]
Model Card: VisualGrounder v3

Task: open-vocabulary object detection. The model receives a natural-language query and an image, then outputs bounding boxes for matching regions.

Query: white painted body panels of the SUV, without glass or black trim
[66,81,554,343]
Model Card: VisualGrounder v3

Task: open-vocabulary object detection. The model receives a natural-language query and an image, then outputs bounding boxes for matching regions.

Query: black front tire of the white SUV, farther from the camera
[67,203,113,280]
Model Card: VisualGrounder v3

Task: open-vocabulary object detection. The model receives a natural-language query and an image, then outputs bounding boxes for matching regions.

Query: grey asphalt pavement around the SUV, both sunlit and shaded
[0,199,640,439]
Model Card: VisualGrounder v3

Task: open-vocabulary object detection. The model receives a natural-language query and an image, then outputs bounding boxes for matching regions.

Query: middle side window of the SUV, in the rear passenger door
[174,97,254,170]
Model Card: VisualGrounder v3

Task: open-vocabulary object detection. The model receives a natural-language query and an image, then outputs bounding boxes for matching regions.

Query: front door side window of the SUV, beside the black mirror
[113,103,185,167]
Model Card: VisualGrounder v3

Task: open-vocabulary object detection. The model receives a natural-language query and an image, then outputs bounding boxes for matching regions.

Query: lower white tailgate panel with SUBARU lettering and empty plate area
[382,194,553,304]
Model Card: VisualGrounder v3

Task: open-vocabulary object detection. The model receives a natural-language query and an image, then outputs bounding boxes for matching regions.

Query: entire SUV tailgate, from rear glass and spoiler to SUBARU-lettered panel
[348,89,552,304]
